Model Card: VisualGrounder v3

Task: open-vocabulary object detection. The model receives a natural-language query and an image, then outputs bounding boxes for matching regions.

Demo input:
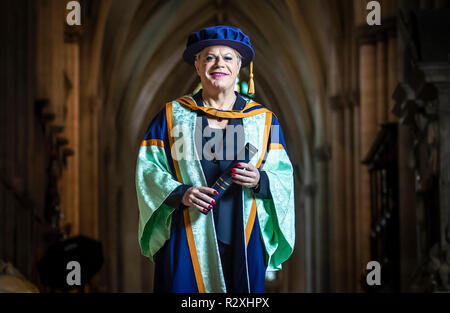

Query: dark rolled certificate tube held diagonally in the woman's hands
[201,142,258,214]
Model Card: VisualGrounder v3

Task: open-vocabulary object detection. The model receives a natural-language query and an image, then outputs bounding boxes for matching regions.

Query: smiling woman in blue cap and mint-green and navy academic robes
[136,26,295,293]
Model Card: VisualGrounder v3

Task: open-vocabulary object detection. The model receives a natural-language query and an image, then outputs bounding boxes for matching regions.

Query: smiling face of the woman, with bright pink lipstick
[195,46,241,92]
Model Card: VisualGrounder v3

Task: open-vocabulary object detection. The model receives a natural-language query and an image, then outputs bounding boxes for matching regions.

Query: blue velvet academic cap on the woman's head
[183,25,255,67]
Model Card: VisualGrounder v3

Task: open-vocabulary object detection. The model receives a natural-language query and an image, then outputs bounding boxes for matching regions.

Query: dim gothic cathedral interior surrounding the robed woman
[0,0,450,293]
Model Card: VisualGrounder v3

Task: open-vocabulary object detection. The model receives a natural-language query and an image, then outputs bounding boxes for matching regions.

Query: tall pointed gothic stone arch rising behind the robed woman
[92,0,338,291]
